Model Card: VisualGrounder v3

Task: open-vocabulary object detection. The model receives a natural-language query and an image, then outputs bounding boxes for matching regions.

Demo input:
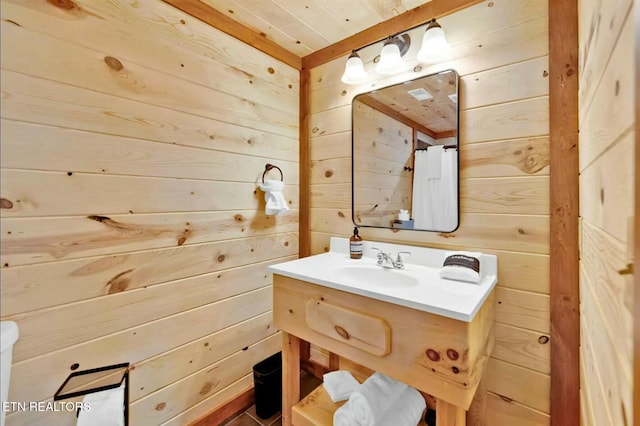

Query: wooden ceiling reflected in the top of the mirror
[356,72,458,138]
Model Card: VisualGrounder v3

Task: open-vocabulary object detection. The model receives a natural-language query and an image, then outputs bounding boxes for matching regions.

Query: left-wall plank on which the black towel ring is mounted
[0,120,299,185]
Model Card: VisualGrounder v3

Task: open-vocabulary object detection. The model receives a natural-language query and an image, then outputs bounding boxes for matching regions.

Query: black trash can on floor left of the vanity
[253,352,282,419]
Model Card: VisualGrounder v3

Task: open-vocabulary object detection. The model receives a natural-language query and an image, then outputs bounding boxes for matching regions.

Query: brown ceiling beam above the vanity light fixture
[302,0,484,69]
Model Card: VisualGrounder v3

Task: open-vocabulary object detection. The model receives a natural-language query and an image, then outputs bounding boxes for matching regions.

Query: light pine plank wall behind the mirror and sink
[309,0,550,426]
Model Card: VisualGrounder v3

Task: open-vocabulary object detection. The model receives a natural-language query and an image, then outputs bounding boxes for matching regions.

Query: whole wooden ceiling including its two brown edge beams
[163,0,484,70]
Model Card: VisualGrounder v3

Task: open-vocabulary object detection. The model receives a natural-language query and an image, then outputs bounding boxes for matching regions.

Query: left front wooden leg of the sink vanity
[282,331,300,426]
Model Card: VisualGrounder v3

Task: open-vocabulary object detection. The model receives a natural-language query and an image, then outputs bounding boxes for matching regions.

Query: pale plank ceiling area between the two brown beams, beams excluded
[199,0,430,57]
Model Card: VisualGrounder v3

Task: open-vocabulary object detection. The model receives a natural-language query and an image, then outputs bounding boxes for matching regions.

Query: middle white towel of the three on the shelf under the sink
[348,372,407,426]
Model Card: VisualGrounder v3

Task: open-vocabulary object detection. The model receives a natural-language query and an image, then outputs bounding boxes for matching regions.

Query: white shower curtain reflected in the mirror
[412,145,458,231]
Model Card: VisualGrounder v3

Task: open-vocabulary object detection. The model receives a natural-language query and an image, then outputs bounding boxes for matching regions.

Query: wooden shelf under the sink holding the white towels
[291,385,427,426]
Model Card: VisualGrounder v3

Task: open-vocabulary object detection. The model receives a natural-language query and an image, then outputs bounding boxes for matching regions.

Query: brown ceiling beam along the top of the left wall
[163,0,302,70]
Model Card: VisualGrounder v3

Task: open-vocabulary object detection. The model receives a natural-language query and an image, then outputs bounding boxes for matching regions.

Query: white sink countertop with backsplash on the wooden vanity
[269,237,498,322]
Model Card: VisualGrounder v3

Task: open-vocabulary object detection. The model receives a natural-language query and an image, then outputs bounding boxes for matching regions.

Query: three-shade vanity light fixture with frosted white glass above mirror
[340,19,451,84]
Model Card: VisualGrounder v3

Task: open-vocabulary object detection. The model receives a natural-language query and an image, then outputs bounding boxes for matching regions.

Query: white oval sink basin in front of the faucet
[332,266,420,288]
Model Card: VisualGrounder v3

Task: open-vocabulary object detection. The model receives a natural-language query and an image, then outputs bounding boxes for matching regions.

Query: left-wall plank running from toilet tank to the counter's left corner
[8,262,288,361]
